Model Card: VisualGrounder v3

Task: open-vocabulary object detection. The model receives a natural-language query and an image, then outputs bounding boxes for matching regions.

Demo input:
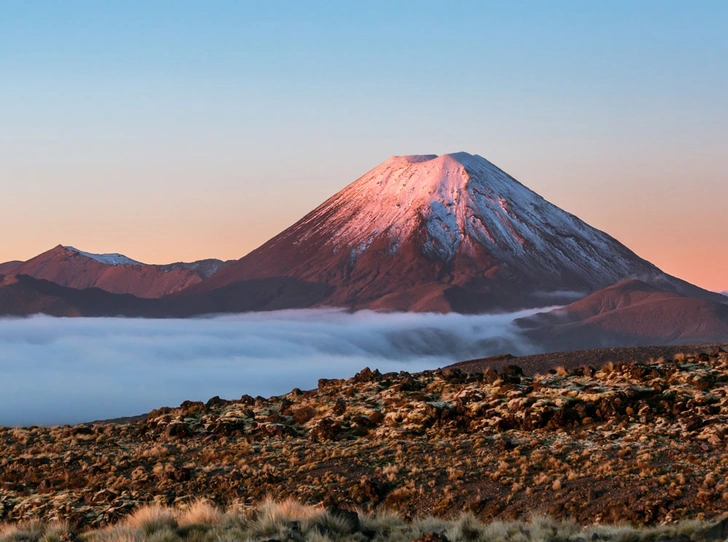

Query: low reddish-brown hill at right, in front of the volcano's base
[518,280,728,351]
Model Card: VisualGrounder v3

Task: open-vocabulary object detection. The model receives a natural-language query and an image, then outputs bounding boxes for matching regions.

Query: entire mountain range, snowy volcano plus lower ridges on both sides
[0,153,728,349]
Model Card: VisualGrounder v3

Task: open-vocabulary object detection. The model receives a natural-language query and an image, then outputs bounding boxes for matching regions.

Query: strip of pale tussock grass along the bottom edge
[0,500,711,542]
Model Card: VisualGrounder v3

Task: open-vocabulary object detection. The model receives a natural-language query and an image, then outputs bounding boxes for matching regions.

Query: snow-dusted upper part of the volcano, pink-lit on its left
[284,152,655,283]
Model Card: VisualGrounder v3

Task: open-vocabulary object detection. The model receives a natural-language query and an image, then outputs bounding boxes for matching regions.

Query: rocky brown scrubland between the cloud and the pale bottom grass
[0,347,728,530]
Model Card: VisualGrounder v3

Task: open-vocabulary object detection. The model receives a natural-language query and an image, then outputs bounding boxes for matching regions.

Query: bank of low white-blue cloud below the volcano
[0,310,536,425]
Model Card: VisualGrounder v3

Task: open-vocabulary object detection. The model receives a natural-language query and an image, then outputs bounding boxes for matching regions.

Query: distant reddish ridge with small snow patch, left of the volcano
[0,245,233,298]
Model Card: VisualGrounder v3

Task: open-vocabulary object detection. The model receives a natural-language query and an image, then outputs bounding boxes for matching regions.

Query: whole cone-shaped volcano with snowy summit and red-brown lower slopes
[183,153,716,312]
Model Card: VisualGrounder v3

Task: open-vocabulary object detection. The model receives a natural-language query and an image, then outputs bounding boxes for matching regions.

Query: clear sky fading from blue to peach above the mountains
[0,0,728,290]
